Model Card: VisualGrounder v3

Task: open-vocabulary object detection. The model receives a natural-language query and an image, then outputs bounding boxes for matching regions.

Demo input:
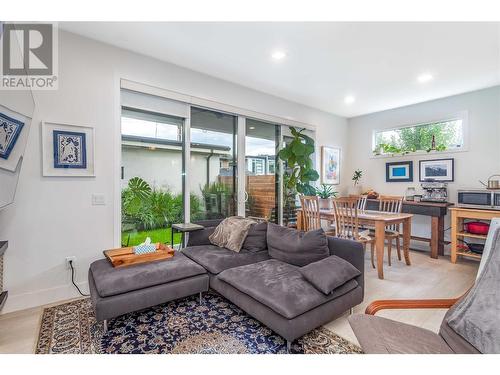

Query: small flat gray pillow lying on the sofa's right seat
[299,255,361,294]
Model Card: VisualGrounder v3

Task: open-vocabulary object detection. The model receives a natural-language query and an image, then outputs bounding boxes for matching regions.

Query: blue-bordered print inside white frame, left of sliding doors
[53,130,87,169]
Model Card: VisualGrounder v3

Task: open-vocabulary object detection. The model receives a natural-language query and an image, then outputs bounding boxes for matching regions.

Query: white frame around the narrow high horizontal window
[370,111,469,159]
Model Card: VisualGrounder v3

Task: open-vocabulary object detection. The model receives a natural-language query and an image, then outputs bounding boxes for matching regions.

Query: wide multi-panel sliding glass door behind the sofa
[120,90,314,246]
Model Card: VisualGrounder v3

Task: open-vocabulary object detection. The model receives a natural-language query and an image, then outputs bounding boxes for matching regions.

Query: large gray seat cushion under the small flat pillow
[217,259,358,319]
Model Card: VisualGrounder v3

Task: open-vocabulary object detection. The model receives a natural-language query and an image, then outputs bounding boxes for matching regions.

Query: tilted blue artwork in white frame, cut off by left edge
[0,105,31,172]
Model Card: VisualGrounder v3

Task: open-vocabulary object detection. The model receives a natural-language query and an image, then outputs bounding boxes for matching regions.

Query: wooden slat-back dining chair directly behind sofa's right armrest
[333,197,375,267]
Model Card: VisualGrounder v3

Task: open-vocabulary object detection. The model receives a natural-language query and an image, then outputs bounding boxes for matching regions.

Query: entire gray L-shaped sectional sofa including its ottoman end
[89,220,364,348]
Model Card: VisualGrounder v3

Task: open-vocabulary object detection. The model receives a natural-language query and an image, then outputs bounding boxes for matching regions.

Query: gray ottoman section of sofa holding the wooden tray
[89,252,208,330]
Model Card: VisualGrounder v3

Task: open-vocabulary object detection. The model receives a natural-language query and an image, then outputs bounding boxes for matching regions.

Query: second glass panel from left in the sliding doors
[189,107,237,222]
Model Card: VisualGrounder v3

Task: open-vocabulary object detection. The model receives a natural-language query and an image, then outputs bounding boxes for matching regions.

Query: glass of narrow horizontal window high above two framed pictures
[373,119,464,155]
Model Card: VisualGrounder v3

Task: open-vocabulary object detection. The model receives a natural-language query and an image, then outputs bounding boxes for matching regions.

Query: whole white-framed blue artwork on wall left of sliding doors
[42,122,95,177]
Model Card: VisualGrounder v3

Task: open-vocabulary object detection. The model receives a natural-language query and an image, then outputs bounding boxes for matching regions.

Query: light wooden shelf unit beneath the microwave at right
[450,207,500,263]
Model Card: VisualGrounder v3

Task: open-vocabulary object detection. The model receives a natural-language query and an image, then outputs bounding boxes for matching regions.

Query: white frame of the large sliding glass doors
[117,81,319,247]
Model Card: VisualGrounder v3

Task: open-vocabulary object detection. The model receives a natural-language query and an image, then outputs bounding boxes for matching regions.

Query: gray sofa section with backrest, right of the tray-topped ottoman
[182,221,364,352]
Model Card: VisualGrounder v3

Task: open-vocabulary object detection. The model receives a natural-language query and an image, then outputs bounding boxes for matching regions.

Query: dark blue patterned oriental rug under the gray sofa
[35,292,361,354]
